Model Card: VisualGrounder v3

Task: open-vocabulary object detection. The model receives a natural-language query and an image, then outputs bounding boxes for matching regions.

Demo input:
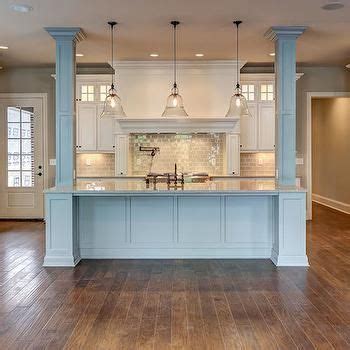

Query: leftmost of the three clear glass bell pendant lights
[101,21,126,118]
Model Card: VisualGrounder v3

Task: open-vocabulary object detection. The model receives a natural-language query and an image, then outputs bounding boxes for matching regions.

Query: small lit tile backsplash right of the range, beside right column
[241,153,275,176]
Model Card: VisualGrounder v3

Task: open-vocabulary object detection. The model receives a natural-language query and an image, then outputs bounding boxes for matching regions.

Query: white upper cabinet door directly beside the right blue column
[258,103,275,151]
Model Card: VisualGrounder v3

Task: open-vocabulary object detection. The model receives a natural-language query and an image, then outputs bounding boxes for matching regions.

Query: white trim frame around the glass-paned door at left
[0,92,49,202]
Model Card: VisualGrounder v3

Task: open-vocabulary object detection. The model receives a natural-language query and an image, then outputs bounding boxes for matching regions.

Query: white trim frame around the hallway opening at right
[306,91,350,220]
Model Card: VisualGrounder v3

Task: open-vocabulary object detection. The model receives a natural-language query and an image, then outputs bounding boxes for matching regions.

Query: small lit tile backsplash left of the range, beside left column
[76,153,114,177]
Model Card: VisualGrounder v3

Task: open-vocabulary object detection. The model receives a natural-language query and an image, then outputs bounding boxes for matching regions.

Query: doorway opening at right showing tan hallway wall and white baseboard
[307,93,350,219]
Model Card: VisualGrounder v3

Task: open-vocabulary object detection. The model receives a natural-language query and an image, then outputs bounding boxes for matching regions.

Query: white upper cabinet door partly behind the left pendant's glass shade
[97,106,115,152]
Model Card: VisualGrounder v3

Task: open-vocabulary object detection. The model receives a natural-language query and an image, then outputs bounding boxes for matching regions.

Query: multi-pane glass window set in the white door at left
[7,107,34,187]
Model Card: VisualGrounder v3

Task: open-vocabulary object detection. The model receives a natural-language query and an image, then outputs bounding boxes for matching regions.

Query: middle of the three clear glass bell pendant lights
[162,21,188,117]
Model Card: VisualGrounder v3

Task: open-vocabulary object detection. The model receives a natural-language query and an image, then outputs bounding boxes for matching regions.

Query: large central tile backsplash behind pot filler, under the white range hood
[129,134,225,175]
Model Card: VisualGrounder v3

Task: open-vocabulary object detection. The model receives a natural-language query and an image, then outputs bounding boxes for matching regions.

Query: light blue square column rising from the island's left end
[45,27,84,187]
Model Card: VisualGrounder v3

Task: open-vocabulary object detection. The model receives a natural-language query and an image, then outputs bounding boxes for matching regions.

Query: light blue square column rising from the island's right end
[265,26,306,186]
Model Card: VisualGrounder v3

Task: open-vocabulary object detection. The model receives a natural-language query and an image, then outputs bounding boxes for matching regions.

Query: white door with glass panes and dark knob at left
[0,97,45,218]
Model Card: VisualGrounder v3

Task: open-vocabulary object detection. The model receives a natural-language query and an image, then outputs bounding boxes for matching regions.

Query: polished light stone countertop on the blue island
[46,178,305,195]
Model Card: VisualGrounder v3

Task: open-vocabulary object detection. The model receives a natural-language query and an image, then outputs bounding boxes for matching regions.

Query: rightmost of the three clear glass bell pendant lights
[226,21,250,118]
